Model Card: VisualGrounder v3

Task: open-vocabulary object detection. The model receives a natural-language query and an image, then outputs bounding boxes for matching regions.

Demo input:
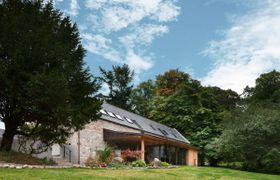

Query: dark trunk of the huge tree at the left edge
[0,122,17,151]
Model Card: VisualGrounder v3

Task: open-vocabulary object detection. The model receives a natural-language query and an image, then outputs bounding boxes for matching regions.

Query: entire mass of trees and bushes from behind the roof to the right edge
[131,70,280,172]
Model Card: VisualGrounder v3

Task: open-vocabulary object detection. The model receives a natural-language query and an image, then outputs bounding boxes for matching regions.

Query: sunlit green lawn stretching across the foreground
[0,166,280,180]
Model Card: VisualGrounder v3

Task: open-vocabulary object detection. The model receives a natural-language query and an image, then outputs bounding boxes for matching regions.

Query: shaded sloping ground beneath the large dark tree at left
[0,151,55,165]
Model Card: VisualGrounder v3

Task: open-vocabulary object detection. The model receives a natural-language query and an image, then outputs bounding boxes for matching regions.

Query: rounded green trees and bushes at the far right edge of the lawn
[210,71,280,173]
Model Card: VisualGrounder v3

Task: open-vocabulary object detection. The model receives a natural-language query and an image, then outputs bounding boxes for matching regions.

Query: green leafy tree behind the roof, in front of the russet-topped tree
[150,80,221,165]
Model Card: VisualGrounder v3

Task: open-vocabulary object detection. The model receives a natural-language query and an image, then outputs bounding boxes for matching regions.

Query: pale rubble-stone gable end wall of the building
[68,120,139,164]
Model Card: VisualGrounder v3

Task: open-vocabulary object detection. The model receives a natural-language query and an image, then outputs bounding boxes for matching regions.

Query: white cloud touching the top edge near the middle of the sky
[99,0,180,32]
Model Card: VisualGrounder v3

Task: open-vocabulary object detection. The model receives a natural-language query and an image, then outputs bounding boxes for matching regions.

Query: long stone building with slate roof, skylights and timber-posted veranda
[0,103,198,166]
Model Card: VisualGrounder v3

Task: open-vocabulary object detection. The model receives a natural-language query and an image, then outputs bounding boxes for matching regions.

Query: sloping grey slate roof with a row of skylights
[101,102,190,144]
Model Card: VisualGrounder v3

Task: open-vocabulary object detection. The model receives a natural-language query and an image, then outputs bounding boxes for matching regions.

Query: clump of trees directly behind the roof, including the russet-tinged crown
[131,69,236,165]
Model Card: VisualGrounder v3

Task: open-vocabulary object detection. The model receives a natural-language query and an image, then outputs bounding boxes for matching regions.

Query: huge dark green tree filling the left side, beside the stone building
[0,0,101,151]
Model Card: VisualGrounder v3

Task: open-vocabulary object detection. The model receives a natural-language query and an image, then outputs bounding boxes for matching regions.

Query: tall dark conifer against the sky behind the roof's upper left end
[99,64,134,110]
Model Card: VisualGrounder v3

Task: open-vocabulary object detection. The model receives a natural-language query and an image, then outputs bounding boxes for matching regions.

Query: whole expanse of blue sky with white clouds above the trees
[52,0,280,93]
